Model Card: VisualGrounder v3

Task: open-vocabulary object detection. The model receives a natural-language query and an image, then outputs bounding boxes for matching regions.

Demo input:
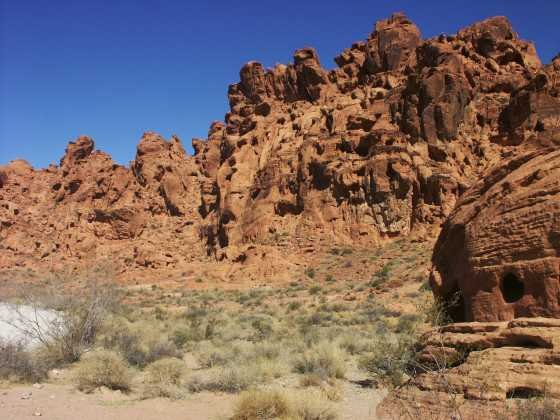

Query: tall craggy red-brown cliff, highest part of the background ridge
[197,14,556,256]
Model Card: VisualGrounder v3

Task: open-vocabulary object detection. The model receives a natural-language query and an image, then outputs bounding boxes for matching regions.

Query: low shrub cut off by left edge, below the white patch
[0,340,49,382]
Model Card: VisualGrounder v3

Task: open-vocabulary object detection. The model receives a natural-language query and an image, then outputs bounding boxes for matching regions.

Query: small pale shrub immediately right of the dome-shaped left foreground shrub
[144,357,185,399]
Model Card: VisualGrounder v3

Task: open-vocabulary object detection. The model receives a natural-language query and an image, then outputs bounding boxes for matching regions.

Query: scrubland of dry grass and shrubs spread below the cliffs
[0,240,529,419]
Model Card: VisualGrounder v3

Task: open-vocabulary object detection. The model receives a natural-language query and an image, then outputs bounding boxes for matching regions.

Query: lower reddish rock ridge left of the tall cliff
[0,133,204,277]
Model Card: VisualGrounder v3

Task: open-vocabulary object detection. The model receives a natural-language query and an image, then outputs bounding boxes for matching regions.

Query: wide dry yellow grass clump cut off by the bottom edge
[231,389,338,420]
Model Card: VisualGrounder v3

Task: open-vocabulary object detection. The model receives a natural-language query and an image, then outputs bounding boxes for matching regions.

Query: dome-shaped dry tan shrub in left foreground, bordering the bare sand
[73,349,131,392]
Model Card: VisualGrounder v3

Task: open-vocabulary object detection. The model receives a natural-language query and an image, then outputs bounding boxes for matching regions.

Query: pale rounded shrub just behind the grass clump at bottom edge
[294,342,346,378]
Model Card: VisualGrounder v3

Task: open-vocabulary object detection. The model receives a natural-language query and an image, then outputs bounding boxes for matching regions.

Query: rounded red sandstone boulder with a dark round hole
[431,147,560,321]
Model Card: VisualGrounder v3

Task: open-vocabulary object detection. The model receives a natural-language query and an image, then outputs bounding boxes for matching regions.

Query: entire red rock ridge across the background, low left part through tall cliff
[0,14,560,276]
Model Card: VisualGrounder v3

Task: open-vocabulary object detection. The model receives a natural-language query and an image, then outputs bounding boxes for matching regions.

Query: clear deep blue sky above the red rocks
[0,0,560,167]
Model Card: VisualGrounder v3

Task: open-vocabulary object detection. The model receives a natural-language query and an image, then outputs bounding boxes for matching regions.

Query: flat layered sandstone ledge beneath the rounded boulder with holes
[378,318,560,419]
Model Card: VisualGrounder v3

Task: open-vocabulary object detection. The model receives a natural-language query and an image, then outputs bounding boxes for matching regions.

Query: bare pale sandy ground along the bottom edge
[0,382,383,420]
